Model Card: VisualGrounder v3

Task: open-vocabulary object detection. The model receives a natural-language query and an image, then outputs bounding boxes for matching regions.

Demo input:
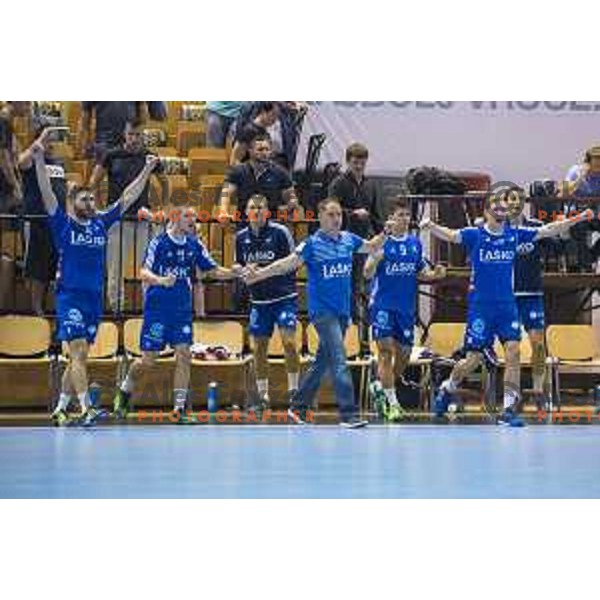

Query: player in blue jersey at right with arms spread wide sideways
[421,188,593,427]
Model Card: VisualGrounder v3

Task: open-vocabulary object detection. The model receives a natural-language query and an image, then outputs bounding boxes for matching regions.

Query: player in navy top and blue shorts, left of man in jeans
[235,194,300,410]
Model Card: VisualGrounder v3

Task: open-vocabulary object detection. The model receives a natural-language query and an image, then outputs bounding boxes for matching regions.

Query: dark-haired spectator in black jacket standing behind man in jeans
[329,144,383,322]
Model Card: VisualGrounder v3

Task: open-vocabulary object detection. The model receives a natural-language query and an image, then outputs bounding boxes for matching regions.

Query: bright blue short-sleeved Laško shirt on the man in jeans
[296,230,365,318]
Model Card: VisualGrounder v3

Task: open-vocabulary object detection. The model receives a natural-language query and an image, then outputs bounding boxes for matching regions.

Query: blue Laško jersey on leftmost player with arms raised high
[48,203,121,295]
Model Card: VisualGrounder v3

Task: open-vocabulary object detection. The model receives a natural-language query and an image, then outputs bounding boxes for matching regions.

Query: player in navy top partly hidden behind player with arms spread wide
[506,187,552,410]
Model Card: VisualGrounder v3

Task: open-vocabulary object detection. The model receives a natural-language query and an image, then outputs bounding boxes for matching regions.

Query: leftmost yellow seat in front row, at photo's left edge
[0,316,57,409]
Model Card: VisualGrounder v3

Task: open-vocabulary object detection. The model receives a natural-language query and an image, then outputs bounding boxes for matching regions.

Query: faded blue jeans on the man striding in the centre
[292,315,358,419]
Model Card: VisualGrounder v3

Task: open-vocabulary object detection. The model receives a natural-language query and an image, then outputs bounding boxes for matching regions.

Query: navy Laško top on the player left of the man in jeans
[235,222,297,304]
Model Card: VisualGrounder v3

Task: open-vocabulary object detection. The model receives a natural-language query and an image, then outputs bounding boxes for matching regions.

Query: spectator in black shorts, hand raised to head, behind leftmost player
[19,124,67,316]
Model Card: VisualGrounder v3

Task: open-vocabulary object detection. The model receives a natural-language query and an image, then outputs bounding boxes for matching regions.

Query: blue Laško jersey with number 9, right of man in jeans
[369,235,426,315]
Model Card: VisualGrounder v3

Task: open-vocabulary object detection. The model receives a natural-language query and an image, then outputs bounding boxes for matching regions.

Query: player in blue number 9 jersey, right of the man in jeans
[364,200,446,422]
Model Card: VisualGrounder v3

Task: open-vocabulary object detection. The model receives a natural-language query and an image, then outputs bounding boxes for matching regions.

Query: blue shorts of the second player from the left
[140,312,194,352]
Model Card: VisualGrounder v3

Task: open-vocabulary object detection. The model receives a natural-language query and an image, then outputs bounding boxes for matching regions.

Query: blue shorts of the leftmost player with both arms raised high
[56,290,102,344]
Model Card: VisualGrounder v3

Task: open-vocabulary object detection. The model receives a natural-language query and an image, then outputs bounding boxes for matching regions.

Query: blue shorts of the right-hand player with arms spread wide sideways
[464,302,521,352]
